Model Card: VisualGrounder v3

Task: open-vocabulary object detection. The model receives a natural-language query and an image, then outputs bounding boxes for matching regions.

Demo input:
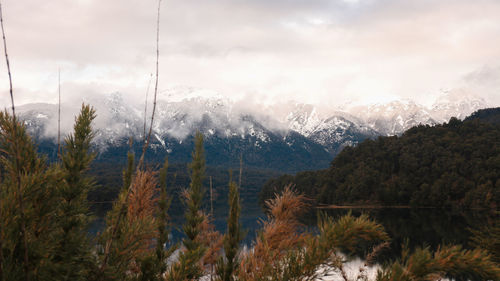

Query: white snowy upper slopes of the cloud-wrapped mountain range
[13,91,486,155]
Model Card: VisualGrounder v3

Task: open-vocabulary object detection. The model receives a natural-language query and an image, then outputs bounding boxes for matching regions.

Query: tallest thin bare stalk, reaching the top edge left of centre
[100,0,161,279]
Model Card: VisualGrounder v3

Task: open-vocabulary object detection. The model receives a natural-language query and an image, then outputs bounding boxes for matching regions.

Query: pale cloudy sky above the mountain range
[0,0,500,106]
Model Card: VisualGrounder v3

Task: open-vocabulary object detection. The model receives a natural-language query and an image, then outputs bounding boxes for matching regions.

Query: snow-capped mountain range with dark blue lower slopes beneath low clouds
[12,89,492,171]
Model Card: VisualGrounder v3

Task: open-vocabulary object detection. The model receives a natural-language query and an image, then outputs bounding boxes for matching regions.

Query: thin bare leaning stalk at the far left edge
[0,2,29,281]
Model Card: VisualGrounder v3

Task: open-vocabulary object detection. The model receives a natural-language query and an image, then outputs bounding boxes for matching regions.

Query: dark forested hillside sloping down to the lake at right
[261,108,500,208]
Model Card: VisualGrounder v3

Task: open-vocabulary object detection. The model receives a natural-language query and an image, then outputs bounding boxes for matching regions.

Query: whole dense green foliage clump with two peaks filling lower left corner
[0,106,95,280]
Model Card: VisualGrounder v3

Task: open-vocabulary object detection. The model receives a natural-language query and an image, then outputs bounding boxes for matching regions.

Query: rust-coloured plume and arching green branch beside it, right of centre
[239,187,389,281]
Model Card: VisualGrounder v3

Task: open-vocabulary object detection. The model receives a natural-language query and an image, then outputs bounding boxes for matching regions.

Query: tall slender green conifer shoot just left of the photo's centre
[167,132,206,281]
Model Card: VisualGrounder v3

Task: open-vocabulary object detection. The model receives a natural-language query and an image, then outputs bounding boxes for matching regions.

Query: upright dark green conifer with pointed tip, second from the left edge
[54,105,96,280]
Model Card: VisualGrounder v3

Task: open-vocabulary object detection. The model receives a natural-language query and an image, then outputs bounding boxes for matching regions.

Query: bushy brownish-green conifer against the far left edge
[0,112,61,280]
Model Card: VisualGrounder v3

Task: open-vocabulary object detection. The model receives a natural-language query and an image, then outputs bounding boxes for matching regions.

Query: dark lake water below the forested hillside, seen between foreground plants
[89,205,492,259]
